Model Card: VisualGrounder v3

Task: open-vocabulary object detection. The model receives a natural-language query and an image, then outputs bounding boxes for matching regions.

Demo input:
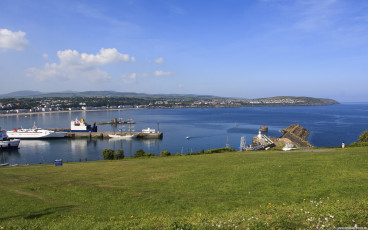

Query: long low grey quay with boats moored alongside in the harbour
[65,132,163,139]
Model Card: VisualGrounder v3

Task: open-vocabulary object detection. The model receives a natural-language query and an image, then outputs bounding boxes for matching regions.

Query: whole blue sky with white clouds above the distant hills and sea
[0,0,368,102]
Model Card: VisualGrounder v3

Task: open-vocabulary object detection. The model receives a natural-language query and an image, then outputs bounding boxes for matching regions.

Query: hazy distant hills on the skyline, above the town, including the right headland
[0,90,339,106]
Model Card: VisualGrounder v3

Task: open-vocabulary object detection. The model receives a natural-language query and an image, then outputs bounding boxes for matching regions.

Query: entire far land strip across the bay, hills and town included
[0,91,339,115]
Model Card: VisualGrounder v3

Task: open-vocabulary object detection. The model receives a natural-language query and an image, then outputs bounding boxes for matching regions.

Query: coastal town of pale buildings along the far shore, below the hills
[0,96,337,115]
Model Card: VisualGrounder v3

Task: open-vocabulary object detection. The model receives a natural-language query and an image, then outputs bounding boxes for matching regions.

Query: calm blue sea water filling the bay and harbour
[0,104,368,164]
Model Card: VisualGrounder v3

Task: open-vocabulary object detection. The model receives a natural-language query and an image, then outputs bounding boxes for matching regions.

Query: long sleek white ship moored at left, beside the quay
[6,125,67,139]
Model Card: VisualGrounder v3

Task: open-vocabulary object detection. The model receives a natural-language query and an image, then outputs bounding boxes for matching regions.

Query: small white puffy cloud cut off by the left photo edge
[0,29,28,50]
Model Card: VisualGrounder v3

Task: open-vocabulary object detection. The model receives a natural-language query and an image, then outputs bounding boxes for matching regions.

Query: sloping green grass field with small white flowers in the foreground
[0,147,368,229]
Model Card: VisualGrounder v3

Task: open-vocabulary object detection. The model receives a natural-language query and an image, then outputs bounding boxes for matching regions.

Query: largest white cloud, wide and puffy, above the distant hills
[27,48,131,82]
